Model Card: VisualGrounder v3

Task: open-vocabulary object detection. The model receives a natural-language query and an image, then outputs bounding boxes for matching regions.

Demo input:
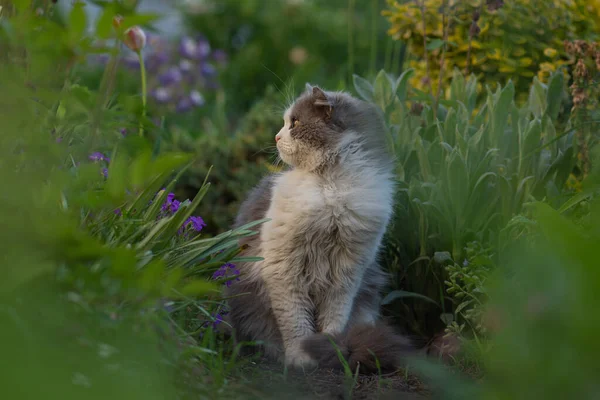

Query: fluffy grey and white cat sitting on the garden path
[227,84,409,370]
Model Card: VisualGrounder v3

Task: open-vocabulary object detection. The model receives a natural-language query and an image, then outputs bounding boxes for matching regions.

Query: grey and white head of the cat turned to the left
[275,84,385,171]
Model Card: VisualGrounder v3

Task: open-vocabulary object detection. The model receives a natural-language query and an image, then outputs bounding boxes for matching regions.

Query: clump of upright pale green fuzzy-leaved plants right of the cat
[355,70,575,340]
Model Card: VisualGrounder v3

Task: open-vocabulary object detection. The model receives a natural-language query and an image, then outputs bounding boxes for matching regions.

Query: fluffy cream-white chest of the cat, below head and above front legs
[261,170,392,276]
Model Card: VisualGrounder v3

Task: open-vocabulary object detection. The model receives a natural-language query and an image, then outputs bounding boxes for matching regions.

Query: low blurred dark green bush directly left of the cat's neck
[162,86,285,233]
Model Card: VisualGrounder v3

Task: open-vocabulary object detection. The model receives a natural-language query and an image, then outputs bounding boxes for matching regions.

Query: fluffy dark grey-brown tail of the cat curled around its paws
[303,321,417,373]
